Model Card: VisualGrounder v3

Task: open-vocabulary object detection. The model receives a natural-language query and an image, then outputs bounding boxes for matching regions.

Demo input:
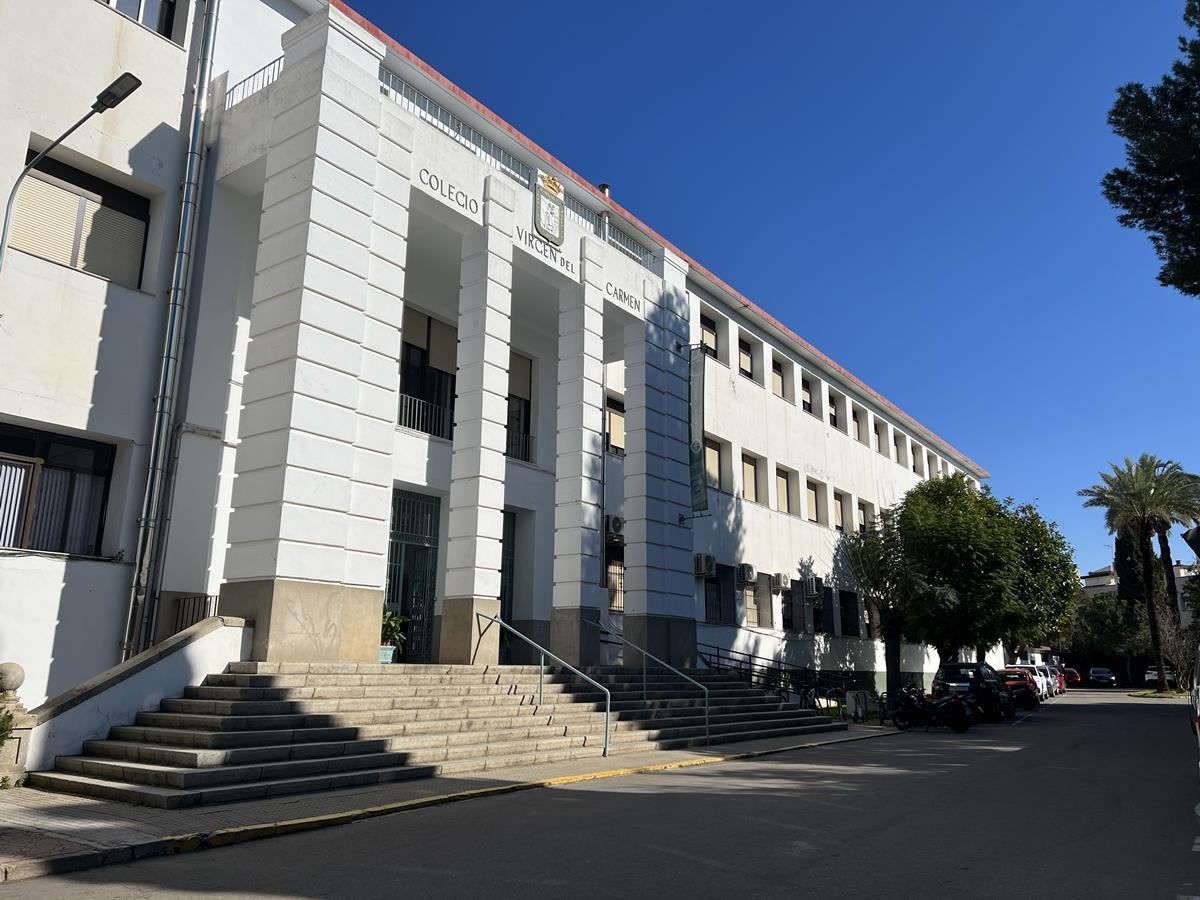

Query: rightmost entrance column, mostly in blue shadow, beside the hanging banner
[624,251,696,666]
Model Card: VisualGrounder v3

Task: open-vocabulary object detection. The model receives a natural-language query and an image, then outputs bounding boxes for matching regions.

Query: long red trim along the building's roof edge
[329,0,990,478]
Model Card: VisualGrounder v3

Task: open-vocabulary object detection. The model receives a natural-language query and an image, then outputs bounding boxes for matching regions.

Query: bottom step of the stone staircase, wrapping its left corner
[29,766,436,809]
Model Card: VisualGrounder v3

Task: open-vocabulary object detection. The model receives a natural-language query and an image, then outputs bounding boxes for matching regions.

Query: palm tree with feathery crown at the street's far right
[1079,454,1200,691]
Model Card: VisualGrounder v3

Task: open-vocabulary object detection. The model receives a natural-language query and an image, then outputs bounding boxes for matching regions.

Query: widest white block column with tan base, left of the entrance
[220,7,410,661]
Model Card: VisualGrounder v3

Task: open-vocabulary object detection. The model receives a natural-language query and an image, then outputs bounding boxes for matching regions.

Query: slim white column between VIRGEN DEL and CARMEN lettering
[550,236,607,666]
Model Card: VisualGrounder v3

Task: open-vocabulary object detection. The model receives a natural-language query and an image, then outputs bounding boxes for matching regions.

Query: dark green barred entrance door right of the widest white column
[384,488,442,662]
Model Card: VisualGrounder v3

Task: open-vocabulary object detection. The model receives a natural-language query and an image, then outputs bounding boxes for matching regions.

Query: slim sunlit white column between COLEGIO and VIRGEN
[437,175,516,665]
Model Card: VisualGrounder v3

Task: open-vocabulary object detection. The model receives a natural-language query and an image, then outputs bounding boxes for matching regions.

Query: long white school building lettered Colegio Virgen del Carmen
[0,0,988,702]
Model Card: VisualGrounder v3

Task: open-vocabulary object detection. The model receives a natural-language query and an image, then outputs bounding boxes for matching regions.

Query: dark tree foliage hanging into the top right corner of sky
[1100,0,1200,296]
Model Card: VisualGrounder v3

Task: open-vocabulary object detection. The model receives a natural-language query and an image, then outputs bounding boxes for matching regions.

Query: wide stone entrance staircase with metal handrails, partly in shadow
[29,662,846,809]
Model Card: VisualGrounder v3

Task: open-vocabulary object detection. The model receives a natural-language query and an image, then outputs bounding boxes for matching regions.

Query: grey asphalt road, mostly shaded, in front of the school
[0,691,1200,900]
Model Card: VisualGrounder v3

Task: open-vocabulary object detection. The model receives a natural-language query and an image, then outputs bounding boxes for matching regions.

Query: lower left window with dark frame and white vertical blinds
[0,425,115,557]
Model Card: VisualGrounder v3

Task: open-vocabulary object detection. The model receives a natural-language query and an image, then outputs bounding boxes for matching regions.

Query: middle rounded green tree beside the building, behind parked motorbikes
[899,475,1016,661]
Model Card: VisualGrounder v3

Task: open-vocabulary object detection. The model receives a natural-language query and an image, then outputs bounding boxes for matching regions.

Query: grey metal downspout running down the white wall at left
[121,0,221,660]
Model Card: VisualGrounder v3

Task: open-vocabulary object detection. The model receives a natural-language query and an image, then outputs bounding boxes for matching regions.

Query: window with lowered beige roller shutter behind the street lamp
[8,150,150,289]
